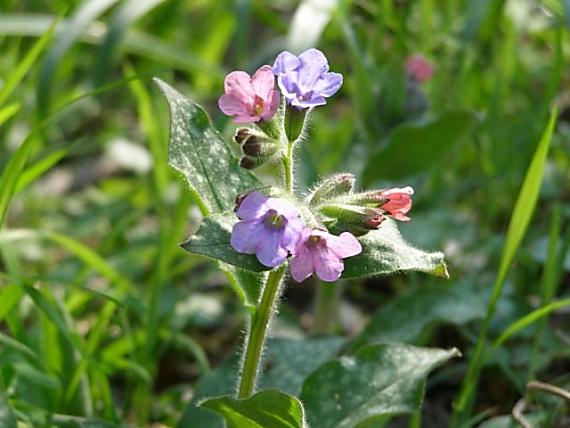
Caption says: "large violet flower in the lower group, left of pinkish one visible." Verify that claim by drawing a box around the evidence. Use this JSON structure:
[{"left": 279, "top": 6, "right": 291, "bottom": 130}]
[{"left": 231, "top": 192, "right": 304, "bottom": 267}]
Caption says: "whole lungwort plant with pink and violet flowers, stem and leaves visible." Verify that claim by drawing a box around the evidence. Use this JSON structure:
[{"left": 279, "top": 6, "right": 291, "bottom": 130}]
[{"left": 157, "top": 49, "right": 458, "bottom": 427}]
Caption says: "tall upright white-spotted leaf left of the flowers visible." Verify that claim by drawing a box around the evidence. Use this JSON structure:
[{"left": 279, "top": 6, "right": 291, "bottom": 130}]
[{"left": 155, "top": 79, "right": 260, "bottom": 214}]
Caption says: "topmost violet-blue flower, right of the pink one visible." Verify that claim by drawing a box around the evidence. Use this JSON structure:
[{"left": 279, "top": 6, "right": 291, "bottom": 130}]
[{"left": 273, "top": 49, "right": 342, "bottom": 109}]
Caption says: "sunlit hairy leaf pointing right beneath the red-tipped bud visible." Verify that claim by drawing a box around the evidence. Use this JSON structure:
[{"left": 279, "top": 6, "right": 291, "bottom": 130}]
[{"left": 342, "top": 219, "right": 448, "bottom": 278}]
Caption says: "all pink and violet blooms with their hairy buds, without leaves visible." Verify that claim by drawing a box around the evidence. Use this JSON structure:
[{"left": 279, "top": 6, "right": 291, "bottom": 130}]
[{"left": 218, "top": 49, "right": 413, "bottom": 282}]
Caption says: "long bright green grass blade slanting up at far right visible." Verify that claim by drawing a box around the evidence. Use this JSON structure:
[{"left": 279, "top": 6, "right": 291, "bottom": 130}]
[{"left": 452, "top": 109, "right": 558, "bottom": 426}]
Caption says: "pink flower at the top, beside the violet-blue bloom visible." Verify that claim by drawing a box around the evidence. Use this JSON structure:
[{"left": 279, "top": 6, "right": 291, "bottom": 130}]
[{"left": 218, "top": 65, "right": 279, "bottom": 123}]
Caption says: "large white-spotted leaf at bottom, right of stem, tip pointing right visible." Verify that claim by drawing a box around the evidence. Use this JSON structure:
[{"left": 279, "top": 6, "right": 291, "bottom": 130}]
[{"left": 301, "top": 345, "right": 460, "bottom": 428}]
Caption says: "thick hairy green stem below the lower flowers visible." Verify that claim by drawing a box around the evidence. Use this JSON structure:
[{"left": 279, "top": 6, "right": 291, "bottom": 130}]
[{"left": 238, "top": 265, "right": 286, "bottom": 398}]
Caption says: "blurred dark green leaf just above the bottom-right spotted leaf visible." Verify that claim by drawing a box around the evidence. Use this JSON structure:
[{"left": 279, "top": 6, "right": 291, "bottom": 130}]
[{"left": 351, "top": 282, "right": 487, "bottom": 349}]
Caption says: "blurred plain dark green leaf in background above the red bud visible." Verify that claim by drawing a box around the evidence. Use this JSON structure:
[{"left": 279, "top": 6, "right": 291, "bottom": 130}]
[{"left": 363, "top": 111, "right": 475, "bottom": 183}]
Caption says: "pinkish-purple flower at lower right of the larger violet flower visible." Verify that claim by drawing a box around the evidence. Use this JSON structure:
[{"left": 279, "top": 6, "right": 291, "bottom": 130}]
[{"left": 291, "top": 228, "right": 362, "bottom": 282}]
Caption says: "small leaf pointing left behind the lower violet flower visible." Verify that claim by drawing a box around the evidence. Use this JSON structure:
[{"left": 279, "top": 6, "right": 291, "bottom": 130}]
[{"left": 182, "top": 213, "right": 270, "bottom": 272}]
